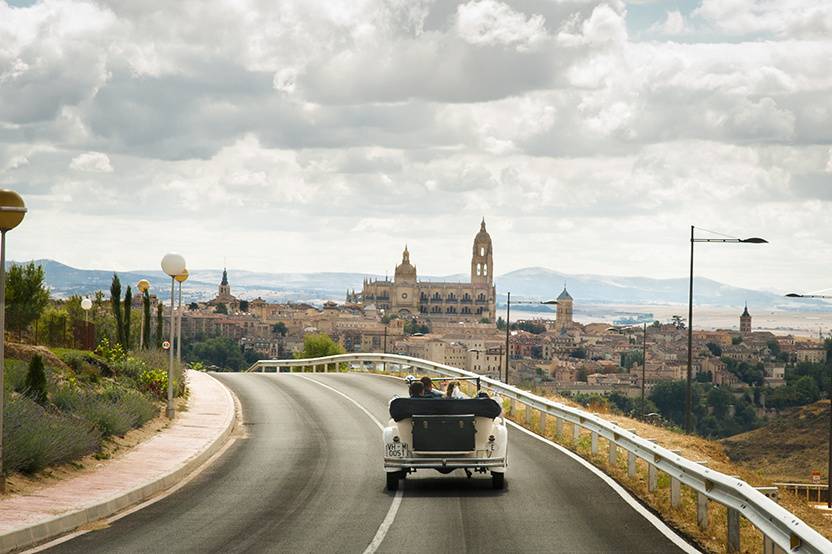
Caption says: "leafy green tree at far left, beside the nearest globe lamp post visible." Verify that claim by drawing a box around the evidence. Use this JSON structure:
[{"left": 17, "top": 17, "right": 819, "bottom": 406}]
[{"left": 6, "top": 262, "right": 49, "bottom": 339}]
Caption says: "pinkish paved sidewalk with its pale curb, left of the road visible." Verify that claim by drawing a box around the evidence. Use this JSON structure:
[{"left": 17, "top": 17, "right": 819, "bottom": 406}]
[{"left": 0, "top": 371, "right": 236, "bottom": 552}]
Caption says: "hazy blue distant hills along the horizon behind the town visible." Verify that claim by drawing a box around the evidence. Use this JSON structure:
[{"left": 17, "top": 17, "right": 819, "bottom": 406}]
[{"left": 14, "top": 260, "right": 832, "bottom": 311}]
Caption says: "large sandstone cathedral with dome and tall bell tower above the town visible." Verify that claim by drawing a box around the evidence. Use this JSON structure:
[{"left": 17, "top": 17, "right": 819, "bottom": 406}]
[{"left": 347, "top": 219, "right": 496, "bottom": 322}]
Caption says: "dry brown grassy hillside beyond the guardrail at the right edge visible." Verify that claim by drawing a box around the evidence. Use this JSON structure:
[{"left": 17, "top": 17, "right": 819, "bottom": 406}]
[{"left": 721, "top": 400, "right": 829, "bottom": 482}]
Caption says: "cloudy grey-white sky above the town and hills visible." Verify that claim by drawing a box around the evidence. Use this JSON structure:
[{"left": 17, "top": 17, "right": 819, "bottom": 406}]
[{"left": 0, "top": 0, "right": 832, "bottom": 292}]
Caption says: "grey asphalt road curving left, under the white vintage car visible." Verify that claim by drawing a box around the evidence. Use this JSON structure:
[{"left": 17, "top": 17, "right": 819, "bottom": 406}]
[{"left": 44, "top": 374, "right": 679, "bottom": 554}]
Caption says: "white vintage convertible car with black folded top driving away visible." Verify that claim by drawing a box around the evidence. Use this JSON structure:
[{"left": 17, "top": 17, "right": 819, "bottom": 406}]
[{"left": 383, "top": 382, "right": 508, "bottom": 491}]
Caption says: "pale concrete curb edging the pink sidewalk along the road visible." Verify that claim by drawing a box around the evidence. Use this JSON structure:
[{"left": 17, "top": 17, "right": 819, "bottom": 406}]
[{"left": 0, "top": 373, "right": 238, "bottom": 553}]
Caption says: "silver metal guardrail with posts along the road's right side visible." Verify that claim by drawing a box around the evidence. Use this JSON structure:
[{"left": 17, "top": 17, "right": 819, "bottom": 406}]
[{"left": 248, "top": 353, "right": 832, "bottom": 554}]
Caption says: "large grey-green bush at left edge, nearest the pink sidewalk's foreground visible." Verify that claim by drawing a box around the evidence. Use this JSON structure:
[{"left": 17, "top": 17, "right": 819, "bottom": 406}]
[{"left": 3, "top": 394, "right": 101, "bottom": 473}]
